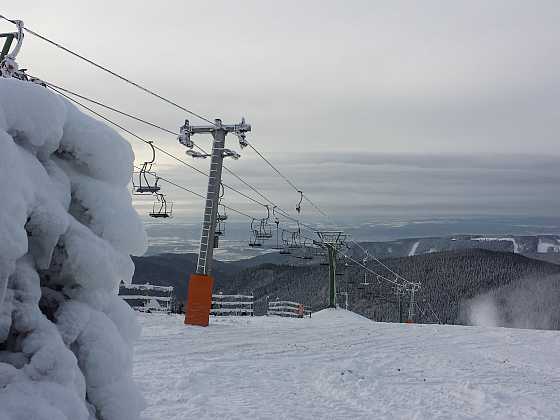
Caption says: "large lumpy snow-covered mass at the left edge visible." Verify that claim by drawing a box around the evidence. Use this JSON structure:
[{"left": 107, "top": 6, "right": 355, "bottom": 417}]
[{"left": 0, "top": 78, "right": 146, "bottom": 420}]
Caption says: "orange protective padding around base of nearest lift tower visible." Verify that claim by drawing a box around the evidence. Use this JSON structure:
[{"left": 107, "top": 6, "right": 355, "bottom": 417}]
[{"left": 185, "top": 274, "right": 214, "bottom": 327}]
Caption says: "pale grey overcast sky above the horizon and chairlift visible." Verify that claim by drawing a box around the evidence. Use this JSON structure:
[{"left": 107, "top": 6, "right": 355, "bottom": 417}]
[{"left": 4, "top": 0, "right": 560, "bottom": 228}]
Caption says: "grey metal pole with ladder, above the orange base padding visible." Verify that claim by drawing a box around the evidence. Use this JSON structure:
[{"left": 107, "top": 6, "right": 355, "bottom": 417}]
[{"left": 196, "top": 119, "right": 226, "bottom": 275}]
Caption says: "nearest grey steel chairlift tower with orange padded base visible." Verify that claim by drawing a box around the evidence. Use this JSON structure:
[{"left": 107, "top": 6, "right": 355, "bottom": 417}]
[{"left": 178, "top": 119, "right": 251, "bottom": 326}]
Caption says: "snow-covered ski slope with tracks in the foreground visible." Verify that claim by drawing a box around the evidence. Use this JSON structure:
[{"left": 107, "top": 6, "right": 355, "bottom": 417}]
[{"left": 134, "top": 310, "right": 560, "bottom": 420}]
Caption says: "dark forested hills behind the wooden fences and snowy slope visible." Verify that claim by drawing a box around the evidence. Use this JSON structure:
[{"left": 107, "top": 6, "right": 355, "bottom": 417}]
[{"left": 134, "top": 249, "right": 560, "bottom": 328}]
